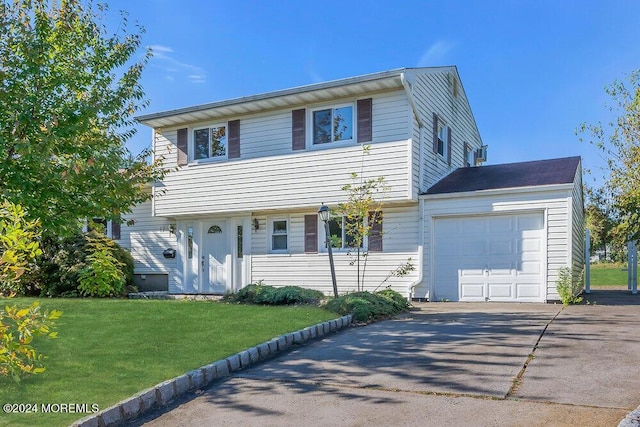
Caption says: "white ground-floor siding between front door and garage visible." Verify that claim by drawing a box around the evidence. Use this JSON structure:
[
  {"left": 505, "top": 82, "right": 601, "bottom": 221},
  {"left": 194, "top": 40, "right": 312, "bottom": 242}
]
[{"left": 251, "top": 207, "right": 418, "bottom": 296}]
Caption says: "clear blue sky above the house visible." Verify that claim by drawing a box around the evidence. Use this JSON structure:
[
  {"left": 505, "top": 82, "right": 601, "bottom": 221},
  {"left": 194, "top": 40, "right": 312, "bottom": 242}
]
[{"left": 107, "top": 0, "right": 640, "bottom": 187}]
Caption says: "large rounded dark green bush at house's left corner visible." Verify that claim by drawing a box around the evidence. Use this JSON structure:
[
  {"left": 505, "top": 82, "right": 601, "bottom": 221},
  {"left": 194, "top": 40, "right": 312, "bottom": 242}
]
[{"left": 30, "top": 231, "right": 134, "bottom": 297}]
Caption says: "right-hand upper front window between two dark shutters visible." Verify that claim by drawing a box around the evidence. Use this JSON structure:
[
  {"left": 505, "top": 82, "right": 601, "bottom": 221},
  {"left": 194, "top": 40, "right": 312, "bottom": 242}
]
[{"left": 311, "top": 104, "right": 353, "bottom": 145}]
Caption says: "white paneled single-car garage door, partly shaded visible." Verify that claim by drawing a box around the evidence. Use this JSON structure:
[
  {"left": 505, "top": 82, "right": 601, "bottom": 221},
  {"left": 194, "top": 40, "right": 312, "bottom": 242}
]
[{"left": 432, "top": 213, "right": 545, "bottom": 302}]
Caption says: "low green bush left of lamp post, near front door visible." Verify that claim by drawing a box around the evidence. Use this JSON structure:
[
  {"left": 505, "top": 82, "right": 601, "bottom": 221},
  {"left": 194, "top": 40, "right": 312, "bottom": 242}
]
[{"left": 225, "top": 282, "right": 324, "bottom": 305}]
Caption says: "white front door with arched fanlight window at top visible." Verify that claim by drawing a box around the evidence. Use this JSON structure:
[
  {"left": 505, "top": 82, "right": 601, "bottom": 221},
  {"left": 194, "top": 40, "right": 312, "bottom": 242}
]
[{"left": 200, "top": 221, "right": 231, "bottom": 294}]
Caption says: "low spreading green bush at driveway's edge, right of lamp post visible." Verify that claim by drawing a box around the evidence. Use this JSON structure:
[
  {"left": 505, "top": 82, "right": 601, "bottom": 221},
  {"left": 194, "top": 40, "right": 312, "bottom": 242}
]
[{"left": 325, "top": 289, "right": 409, "bottom": 322}]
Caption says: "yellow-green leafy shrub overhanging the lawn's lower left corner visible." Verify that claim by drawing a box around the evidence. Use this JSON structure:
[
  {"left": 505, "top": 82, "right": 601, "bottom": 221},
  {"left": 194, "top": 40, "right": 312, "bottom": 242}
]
[{"left": 0, "top": 301, "right": 62, "bottom": 382}]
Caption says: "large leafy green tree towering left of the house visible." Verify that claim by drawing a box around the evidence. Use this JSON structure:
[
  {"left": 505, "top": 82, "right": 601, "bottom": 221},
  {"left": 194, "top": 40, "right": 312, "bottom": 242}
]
[{"left": 0, "top": 0, "right": 161, "bottom": 235}]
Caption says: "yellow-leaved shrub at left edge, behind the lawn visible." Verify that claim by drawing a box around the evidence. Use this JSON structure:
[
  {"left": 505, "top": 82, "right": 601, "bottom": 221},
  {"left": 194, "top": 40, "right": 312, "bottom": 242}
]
[{"left": 0, "top": 200, "right": 42, "bottom": 296}]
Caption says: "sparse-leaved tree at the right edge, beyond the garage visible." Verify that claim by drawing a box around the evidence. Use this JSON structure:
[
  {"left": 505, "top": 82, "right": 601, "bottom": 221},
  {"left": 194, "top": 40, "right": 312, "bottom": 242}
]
[{"left": 578, "top": 70, "right": 640, "bottom": 244}]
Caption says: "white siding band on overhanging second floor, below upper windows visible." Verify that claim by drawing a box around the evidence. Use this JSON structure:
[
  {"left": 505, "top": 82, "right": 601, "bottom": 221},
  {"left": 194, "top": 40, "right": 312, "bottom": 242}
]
[{"left": 155, "top": 140, "right": 410, "bottom": 217}]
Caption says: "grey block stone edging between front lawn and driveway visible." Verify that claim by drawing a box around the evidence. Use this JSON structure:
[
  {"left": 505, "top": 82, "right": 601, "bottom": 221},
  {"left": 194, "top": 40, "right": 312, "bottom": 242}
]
[{"left": 71, "top": 314, "right": 353, "bottom": 427}]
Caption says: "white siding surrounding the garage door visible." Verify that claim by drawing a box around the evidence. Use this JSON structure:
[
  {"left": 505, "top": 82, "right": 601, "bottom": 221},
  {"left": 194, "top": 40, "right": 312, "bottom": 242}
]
[{"left": 422, "top": 185, "right": 573, "bottom": 301}]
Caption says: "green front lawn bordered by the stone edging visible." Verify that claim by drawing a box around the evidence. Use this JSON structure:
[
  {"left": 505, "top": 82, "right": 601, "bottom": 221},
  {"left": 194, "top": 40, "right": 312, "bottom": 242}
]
[{"left": 0, "top": 298, "right": 337, "bottom": 426}]
